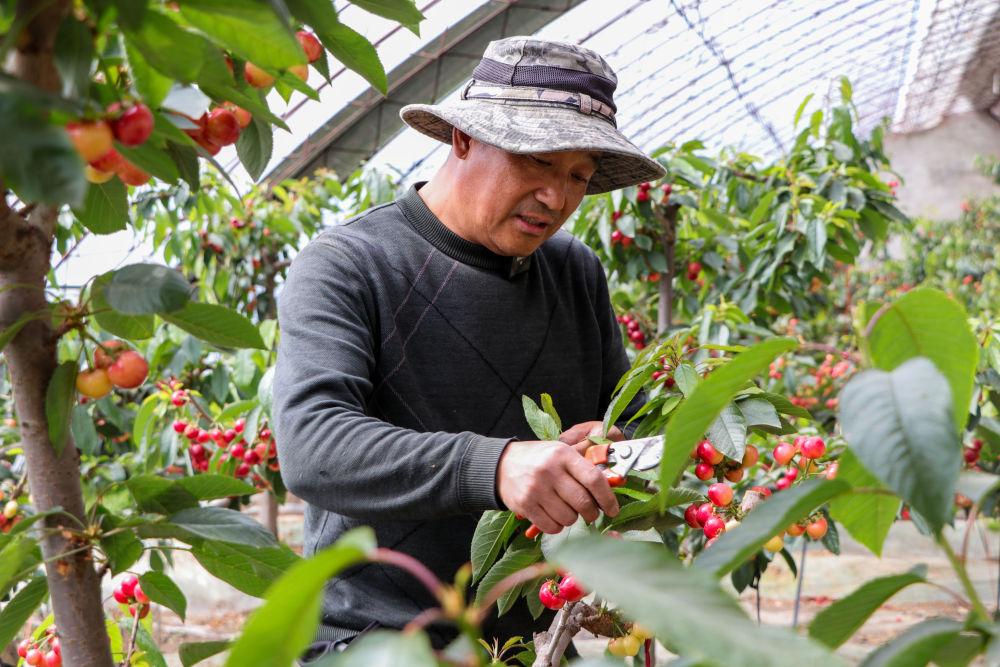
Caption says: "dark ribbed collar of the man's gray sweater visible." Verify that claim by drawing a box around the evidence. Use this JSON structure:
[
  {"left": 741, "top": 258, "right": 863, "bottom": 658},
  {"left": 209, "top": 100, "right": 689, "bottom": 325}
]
[{"left": 397, "top": 181, "right": 531, "bottom": 278}]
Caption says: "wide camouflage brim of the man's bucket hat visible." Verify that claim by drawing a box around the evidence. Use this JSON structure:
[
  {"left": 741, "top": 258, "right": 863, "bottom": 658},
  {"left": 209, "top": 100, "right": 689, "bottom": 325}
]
[{"left": 399, "top": 100, "right": 666, "bottom": 194}]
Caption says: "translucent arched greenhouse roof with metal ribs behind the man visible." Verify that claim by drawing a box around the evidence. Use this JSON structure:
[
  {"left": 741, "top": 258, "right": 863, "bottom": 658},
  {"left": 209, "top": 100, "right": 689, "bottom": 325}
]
[{"left": 240, "top": 0, "right": 1000, "bottom": 188}]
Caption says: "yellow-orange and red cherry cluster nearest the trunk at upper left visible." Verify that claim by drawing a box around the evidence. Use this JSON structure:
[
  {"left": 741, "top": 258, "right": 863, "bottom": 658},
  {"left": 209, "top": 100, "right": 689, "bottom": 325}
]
[{"left": 66, "top": 102, "right": 154, "bottom": 185}]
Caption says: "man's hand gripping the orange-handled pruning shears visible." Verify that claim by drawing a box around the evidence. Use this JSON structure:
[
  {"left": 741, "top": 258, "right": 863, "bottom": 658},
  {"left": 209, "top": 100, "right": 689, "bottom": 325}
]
[{"left": 497, "top": 440, "right": 618, "bottom": 533}]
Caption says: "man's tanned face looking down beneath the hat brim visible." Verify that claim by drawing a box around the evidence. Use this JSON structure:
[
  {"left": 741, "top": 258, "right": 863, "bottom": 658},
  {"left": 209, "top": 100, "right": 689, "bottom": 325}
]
[{"left": 461, "top": 139, "right": 597, "bottom": 257}]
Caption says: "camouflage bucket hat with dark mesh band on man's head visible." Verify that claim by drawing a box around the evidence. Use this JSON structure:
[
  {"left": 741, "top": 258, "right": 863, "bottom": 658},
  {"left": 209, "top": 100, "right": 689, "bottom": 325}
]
[{"left": 399, "top": 37, "right": 665, "bottom": 194}]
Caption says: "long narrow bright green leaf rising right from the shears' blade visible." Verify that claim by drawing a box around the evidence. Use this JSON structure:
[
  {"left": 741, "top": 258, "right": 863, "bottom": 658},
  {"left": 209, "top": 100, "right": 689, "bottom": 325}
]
[{"left": 660, "top": 338, "right": 797, "bottom": 498}]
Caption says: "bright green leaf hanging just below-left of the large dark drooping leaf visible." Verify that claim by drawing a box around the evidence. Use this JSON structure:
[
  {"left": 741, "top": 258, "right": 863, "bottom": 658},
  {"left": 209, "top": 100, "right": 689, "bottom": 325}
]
[{"left": 830, "top": 449, "right": 901, "bottom": 556}]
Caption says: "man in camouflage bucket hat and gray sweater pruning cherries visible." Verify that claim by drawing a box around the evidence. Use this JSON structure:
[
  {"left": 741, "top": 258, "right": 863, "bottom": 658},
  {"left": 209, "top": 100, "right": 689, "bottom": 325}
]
[{"left": 274, "top": 37, "right": 663, "bottom": 660}]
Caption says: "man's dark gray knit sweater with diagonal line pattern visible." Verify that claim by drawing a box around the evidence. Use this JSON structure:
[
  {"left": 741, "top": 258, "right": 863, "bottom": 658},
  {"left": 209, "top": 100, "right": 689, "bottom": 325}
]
[{"left": 273, "top": 183, "right": 637, "bottom": 646}]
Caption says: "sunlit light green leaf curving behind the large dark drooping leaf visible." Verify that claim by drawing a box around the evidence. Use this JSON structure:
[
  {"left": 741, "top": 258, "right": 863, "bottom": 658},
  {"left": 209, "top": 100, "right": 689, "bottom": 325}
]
[{"left": 868, "top": 288, "right": 979, "bottom": 431}]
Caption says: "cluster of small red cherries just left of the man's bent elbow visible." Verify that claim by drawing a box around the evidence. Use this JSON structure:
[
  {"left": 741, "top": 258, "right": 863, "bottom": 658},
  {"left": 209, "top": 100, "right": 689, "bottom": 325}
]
[{"left": 167, "top": 380, "right": 280, "bottom": 488}]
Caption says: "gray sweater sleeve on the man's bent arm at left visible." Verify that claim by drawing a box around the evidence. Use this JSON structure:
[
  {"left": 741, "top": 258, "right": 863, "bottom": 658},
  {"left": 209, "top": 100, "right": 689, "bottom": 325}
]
[{"left": 273, "top": 239, "right": 509, "bottom": 520}]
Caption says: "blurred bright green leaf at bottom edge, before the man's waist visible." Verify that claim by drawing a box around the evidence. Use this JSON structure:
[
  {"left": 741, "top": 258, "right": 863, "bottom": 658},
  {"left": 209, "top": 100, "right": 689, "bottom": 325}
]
[{"left": 226, "top": 528, "right": 376, "bottom": 667}]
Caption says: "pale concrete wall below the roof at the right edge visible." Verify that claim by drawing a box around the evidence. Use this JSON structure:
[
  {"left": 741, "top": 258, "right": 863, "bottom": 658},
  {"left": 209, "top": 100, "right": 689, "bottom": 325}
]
[{"left": 885, "top": 111, "right": 1000, "bottom": 218}]
